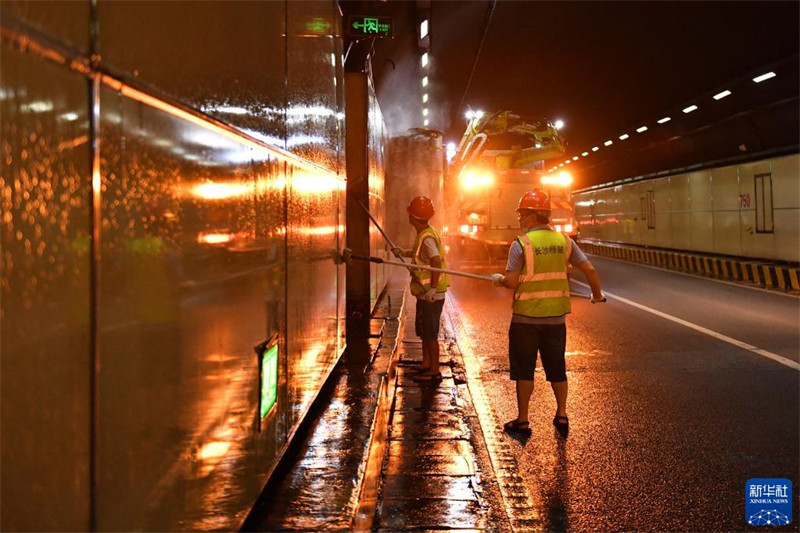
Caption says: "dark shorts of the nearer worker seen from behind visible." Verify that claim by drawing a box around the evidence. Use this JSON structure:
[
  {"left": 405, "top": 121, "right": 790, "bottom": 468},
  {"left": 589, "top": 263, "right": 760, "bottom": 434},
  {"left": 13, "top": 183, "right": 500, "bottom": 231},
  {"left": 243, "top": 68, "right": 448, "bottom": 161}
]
[{"left": 508, "top": 322, "right": 567, "bottom": 383}]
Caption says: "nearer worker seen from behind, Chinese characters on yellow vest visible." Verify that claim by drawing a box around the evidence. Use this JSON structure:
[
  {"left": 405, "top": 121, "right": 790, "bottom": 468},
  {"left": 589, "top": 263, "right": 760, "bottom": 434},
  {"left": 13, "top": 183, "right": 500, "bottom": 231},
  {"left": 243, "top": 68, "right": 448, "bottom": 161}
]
[{"left": 492, "top": 190, "right": 606, "bottom": 436}]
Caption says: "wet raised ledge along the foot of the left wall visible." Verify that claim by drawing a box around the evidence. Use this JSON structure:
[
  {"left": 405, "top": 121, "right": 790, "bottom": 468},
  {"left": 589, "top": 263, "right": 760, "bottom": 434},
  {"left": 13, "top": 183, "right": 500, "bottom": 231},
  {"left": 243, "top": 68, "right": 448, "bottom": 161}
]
[{"left": 240, "top": 281, "right": 407, "bottom": 531}]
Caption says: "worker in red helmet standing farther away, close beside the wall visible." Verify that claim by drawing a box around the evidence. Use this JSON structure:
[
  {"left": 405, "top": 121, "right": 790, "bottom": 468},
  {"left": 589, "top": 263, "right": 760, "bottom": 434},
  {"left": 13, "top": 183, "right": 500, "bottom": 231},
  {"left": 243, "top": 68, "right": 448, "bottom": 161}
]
[{"left": 392, "top": 196, "right": 450, "bottom": 385}]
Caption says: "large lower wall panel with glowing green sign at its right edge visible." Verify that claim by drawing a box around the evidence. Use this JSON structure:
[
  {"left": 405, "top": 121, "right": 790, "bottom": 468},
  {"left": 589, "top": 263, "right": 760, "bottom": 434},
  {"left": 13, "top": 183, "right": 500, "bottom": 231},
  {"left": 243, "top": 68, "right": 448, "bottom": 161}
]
[{"left": 97, "top": 89, "right": 292, "bottom": 530}]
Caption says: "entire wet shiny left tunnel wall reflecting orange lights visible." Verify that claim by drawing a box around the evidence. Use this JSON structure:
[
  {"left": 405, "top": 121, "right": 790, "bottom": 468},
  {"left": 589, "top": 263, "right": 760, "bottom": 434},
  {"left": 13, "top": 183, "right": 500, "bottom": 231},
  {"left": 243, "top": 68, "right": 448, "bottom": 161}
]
[{"left": 0, "top": 1, "right": 384, "bottom": 531}]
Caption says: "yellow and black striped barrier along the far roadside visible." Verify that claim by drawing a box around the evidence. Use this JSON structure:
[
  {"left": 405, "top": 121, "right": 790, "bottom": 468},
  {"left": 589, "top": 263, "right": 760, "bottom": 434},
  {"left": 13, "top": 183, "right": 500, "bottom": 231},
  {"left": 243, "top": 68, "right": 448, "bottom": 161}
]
[{"left": 578, "top": 241, "right": 800, "bottom": 292}]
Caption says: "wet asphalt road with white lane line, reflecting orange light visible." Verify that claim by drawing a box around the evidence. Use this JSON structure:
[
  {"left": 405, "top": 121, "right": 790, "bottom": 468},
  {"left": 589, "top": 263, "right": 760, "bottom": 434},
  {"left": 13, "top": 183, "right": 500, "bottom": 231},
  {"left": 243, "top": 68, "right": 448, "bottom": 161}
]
[{"left": 450, "top": 257, "right": 800, "bottom": 531}]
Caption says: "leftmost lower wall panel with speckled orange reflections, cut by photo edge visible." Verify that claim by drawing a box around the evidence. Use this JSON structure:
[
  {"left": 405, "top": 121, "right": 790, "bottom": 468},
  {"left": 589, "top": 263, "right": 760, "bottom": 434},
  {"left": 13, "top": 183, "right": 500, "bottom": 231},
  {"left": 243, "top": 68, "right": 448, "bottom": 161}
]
[{"left": 0, "top": 40, "right": 92, "bottom": 531}]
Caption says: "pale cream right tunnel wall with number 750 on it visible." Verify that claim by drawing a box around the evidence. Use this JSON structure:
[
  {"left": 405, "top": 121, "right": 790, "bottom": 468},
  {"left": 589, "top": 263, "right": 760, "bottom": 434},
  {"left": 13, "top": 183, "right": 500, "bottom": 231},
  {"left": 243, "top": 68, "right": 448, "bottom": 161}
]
[{"left": 572, "top": 154, "right": 800, "bottom": 262}]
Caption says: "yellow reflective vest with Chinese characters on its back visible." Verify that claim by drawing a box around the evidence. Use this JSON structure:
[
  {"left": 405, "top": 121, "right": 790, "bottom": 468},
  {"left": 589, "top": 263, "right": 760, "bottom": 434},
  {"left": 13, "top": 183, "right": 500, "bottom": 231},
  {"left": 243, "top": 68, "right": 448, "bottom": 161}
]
[{"left": 513, "top": 230, "right": 572, "bottom": 318}]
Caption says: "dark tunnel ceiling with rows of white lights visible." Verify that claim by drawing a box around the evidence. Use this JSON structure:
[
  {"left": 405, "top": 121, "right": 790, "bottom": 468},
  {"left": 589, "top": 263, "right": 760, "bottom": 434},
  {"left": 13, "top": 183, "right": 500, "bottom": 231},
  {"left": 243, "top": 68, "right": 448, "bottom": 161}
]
[{"left": 362, "top": 0, "right": 800, "bottom": 186}]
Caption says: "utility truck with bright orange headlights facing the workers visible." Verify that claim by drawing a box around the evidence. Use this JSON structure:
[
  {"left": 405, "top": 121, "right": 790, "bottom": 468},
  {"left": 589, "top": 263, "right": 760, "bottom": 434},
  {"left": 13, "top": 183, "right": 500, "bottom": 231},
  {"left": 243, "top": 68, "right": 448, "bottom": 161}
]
[{"left": 444, "top": 111, "right": 577, "bottom": 270}]
